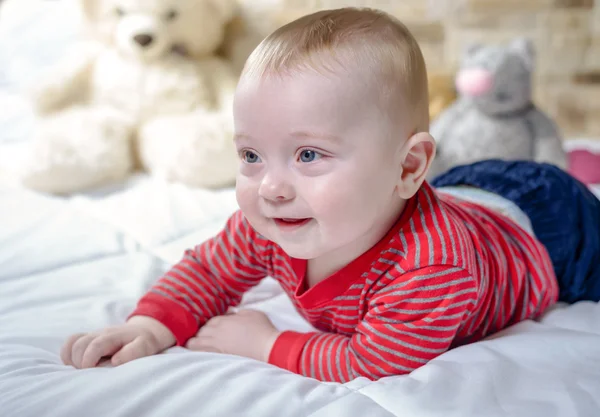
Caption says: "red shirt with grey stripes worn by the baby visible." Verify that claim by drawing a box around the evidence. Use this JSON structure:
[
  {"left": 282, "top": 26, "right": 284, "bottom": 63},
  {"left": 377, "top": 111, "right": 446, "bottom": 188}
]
[{"left": 133, "top": 184, "right": 558, "bottom": 382}]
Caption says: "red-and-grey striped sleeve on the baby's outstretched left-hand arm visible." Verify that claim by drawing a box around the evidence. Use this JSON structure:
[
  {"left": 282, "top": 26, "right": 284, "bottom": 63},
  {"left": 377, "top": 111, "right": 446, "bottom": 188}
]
[{"left": 130, "top": 211, "right": 268, "bottom": 346}]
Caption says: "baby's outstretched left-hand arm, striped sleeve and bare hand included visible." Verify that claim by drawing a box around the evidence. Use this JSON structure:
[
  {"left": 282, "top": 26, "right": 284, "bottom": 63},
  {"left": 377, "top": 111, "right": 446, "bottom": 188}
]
[{"left": 61, "top": 212, "right": 267, "bottom": 368}]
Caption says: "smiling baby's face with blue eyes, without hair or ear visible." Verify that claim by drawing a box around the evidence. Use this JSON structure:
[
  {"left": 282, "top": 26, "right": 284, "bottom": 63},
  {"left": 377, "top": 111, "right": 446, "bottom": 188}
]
[{"left": 234, "top": 68, "right": 402, "bottom": 259}]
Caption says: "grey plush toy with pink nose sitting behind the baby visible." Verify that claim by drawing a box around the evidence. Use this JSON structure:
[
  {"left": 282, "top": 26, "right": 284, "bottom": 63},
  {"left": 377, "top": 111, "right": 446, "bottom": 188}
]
[{"left": 429, "top": 38, "right": 566, "bottom": 178}]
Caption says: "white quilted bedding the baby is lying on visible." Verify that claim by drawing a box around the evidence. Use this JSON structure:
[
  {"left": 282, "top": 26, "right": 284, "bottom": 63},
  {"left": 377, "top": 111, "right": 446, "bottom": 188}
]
[{"left": 0, "top": 0, "right": 600, "bottom": 417}]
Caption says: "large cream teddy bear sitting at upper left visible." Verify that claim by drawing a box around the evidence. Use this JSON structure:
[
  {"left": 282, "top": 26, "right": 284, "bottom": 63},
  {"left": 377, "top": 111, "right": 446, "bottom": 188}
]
[{"left": 20, "top": 0, "right": 238, "bottom": 194}]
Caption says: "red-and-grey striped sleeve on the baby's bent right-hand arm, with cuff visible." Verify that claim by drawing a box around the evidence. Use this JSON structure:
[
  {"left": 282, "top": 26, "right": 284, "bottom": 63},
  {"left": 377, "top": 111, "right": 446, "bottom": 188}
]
[{"left": 269, "top": 266, "right": 477, "bottom": 382}]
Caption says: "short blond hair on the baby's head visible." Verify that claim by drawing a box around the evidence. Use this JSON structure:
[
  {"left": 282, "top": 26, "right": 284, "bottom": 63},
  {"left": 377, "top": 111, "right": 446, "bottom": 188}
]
[{"left": 242, "top": 7, "right": 429, "bottom": 134}]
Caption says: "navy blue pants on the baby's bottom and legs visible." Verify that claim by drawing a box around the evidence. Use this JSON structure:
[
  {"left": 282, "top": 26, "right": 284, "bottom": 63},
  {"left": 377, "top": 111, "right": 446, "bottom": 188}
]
[{"left": 431, "top": 160, "right": 600, "bottom": 303}]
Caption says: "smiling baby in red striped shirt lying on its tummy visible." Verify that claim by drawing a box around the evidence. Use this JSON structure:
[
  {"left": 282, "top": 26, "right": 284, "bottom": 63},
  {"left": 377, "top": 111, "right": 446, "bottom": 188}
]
[{"left": 61, "top": 8, "right": 600, "bottom": 382}]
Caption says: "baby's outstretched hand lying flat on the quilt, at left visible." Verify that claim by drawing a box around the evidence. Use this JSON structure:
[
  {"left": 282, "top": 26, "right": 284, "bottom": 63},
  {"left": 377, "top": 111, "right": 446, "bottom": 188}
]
[{"left": 60, "top": 316, "right": 175, "bottom": 369}]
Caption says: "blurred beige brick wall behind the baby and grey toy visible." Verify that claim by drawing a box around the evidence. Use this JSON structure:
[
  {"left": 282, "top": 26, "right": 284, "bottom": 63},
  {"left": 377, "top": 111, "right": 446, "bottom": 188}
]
[{"left": 240, "top": 0, "right": 600, "bottom": 138}]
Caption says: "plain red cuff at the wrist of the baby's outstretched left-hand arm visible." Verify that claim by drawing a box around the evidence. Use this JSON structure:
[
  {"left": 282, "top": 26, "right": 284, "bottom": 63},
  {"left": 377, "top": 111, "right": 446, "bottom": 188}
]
[{"left": 127, "top": 294, "right": 198, "bottom": 346}]
